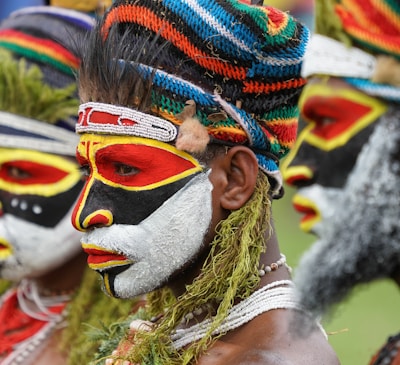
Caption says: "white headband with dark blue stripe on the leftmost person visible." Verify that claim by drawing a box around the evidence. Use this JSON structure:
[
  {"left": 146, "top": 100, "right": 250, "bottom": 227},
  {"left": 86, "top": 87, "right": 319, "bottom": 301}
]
[{"left": 0, "top": 111, "right": 79, "bottom": 156}]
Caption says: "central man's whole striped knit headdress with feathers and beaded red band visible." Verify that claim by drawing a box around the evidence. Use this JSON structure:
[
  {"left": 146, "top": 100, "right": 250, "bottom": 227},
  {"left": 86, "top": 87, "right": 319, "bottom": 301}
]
[{"left": 77, "top": 0, "right": 309, "bottom": 194}]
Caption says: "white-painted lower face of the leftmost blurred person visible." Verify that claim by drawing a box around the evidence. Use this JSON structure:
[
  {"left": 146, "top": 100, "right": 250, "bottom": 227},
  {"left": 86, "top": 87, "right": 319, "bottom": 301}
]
[{"left": 0, "top": 208, "right": 82, "bottom": 281}]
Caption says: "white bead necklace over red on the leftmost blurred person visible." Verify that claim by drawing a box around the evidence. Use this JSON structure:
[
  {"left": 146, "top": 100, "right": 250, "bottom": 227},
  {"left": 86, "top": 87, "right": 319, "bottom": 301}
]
[{"left": 1, "top": 280, "right": 71, "bottom": 365}]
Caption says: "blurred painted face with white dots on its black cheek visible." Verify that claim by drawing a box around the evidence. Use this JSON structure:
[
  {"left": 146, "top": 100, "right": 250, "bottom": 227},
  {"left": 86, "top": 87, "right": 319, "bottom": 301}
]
[{"left": 0, "top": 149, "right": 83, "bottom": 281}]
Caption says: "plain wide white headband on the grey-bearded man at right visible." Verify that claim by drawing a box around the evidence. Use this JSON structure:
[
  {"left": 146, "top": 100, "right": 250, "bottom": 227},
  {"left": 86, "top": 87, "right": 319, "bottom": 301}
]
[{"left": 301, "top": 34, "right": 376, "bottom": 80}]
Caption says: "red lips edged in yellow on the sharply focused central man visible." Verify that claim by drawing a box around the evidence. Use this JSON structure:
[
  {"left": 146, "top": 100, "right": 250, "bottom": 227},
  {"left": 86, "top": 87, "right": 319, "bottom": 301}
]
[{"left": 82, "top": 243, "right": 133, "bottom": 271}]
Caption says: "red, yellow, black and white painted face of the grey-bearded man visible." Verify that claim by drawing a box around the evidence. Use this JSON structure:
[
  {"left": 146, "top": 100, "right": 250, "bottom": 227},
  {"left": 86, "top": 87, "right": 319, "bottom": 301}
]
[{"left": 282, "top": 78, "right": 386, "bottom": 236}]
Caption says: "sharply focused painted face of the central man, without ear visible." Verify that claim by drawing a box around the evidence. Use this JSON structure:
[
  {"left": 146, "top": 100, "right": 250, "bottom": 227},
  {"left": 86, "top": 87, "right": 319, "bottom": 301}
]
[{"left": 72, "top": 135, "right": 212, "bottom": 298}]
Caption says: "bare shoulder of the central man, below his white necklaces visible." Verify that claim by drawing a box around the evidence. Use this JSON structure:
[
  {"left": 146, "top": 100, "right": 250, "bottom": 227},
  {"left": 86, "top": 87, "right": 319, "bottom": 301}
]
[{"left": 197, "top": 310, "right": 340, "bottom": 365}]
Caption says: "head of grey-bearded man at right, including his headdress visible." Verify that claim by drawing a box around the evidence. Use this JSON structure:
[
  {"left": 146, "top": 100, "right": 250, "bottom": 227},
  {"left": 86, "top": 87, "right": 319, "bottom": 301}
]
[{"left": 283, "top": 0, "right": 400, "bottom": 365}]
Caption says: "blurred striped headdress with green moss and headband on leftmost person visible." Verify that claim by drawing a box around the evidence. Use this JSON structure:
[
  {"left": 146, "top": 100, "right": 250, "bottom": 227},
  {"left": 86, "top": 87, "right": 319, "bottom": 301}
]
[{"left": 0, "top": 6, "right": 95, "bottom": 155}]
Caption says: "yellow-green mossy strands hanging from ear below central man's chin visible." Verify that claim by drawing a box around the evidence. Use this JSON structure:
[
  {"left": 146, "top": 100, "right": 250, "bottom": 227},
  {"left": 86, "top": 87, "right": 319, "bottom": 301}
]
[{"left": 119, "top": 172, "right": 272, "bottom": 365}]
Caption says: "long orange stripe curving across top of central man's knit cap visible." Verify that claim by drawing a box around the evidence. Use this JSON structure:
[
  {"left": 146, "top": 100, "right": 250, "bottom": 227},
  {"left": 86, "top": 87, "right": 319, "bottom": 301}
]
[{"left": 103, "top": 5, "right": 246, "bottom": 80}]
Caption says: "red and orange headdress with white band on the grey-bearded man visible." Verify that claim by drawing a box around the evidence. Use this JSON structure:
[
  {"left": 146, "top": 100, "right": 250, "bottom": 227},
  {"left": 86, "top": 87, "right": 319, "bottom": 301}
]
[{"left": 302, "top": 0, "right": 400, "bottom": 102}]
